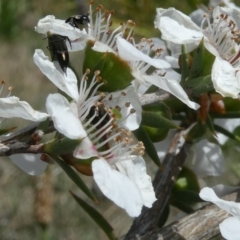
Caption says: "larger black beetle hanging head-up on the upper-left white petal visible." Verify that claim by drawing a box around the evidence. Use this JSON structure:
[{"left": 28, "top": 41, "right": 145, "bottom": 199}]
[{"left": 47, "top": 34, "right": 72, "bottom": 75}]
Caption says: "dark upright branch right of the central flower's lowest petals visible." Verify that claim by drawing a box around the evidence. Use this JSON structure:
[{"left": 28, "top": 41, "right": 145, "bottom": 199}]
[{"left": 125, "top": 131, "right": 192, "bottom": 240}]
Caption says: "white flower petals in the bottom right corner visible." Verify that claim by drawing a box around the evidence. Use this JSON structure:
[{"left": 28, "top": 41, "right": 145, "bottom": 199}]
[{"left": 199, "top": 187, "right": 240, "bottom": 240}]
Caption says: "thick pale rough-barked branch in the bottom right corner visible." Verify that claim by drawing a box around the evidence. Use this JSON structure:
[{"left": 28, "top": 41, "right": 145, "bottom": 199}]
[{"left": 129, "top": 190, "right": 240, "bottom": 240}]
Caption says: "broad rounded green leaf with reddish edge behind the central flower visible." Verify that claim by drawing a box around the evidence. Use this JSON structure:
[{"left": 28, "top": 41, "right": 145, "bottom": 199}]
[{"left": 83, "top": 41, "right": 134, "bottom": 92}]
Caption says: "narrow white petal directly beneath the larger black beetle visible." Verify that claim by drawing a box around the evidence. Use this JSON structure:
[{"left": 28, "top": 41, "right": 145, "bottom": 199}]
[{"left": 33, "top": 49, "right": 78, "bottom": 101}]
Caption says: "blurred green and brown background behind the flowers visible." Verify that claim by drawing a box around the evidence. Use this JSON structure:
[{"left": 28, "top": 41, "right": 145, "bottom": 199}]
[{"left": 0, "top": 0, "right": 240, "bottom": 240}]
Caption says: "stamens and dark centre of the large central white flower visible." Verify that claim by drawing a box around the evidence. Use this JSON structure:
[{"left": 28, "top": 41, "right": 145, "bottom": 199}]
[{"left": 78, "top": 72, "right": 145, "bottom": 163}]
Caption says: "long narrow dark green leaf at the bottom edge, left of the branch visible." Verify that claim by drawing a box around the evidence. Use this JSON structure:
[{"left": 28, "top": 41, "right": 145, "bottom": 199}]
[{"left": 70, "top": 191, "right": 117, "bottom": 240}]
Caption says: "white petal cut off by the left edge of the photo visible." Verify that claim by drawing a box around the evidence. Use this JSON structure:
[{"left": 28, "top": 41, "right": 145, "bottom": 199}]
[{"left": 0, "top": 97, "right": 48, "bottom": 122}]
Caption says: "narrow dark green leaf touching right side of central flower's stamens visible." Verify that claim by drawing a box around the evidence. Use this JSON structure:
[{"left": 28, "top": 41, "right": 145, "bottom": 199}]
[{"left": 133, "top": 126, "right": 161, "bottom": 167}]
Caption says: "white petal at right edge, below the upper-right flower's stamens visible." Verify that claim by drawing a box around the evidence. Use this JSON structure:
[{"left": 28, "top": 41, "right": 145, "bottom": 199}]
[{"left": 212, "top": 57, "right": 240, "bottom": 98}]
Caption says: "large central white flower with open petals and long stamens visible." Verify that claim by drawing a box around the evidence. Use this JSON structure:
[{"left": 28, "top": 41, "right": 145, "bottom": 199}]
[{"left": 34, "top": 53, "right": 156, "bottom": 217}]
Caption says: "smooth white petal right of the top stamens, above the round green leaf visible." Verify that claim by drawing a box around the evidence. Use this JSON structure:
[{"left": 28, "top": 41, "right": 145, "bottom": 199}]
[{"left": 117, "top": 37, "right": 171, "bottom": 68}]
